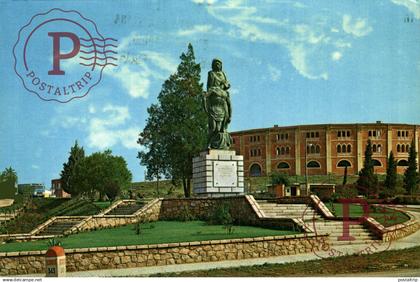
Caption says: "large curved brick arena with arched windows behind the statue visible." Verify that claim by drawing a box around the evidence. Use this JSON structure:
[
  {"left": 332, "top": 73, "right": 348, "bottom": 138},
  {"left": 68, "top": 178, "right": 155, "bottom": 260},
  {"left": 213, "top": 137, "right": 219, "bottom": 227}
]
[{"left": 231, "top": 121, "right": 420, "bottom": 176}]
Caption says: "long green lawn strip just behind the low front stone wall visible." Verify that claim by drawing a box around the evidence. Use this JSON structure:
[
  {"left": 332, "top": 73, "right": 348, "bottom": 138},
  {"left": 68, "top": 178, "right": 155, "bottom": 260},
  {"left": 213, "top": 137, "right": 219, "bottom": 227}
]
[{"left": 0, "top": 221, "right": 298, "bottom": 252}]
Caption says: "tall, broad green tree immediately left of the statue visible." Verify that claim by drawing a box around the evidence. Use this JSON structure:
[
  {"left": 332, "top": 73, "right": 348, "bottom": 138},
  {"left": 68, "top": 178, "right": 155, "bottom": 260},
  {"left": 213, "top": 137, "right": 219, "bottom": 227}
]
[{"left": 138, "top": 44, "right": 207, "bottom": 197}]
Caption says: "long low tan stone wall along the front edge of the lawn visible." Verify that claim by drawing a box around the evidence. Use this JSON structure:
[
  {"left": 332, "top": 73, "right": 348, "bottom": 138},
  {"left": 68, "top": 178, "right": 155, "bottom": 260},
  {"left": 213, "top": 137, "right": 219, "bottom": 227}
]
[{"left": 0, "top": 235, "right": 328, "bottom": 276}]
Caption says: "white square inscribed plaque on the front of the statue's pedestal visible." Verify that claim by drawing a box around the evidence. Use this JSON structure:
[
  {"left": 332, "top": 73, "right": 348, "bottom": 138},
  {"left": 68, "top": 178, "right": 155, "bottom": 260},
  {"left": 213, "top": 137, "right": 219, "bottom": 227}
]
[{"left": 213, "top": 161, "right": 238, "bottom": 187}]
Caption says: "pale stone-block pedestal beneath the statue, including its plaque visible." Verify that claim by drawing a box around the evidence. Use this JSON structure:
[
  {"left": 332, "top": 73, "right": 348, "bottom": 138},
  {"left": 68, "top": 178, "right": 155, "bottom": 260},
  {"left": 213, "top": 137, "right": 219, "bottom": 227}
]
[{"left": 193, "top": 150, "right": 244, "bottom": 197}]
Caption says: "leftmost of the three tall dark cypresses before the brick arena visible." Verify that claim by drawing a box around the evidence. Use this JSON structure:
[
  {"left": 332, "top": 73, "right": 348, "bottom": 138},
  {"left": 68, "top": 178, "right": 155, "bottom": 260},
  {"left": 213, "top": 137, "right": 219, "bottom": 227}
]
[{"left": 357, "top": 139, "right": 378, "bottom": 196}]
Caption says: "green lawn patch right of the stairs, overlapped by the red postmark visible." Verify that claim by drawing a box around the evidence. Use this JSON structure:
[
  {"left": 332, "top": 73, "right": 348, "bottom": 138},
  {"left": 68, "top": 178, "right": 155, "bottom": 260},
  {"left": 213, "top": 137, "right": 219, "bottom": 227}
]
[{"left": 326, "top": 203, "right": 410, "bottom": 227}]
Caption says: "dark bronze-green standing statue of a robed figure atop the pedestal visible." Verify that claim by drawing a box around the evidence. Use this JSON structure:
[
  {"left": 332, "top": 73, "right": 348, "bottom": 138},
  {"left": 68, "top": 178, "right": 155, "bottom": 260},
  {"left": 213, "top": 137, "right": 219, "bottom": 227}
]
[{"left": 203, "top": 59, "right": 232, "bottom": 150}]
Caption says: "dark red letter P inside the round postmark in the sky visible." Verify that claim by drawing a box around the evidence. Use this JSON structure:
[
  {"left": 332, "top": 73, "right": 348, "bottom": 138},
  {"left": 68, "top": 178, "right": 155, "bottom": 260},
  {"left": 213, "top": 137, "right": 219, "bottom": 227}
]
[{"left": 48, "top": 32, "right": 80, "bottom": 75}]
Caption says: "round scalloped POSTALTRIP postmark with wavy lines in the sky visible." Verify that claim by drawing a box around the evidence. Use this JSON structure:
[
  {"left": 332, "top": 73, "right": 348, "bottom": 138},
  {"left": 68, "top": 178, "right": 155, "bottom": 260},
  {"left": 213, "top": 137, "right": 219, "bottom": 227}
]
[{"left": 13, "top": 8, "right": 117, "bottom": 103}]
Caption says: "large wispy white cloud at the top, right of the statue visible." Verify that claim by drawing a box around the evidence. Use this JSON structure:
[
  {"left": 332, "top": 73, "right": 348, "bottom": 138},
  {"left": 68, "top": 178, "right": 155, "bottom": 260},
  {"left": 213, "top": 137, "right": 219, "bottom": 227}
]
[{"left": 207, "top": 0, "right": 354, "bottom": 80}]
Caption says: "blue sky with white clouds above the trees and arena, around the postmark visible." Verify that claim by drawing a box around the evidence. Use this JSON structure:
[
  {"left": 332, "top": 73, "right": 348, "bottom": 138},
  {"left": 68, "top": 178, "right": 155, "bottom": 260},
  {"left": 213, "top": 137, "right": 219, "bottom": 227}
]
[{"left": 0, "top": 0, "right": 420, "bottom": 187}]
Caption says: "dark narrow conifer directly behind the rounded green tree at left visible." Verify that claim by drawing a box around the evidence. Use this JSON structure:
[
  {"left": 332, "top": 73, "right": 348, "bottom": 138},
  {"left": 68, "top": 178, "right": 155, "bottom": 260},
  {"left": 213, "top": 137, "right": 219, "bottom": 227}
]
[{"left": 60, "top": 140, "right": 85, "bottom": 196}]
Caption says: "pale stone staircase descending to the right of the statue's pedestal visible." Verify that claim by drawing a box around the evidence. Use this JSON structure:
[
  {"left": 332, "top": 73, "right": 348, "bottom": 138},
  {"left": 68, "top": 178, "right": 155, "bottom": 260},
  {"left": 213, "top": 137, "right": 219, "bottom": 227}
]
[{"left": 257, "top": 200, "right": 377, "bottom": 245}]
